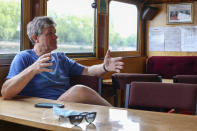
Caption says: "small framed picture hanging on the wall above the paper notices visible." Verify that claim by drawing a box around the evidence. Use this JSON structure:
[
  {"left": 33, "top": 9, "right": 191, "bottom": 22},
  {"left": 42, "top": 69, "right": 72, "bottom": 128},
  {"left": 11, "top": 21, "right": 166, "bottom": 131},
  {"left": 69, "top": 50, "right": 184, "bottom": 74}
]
[{"left": 167, "top": 3, "right": 193, "bottom": 24}]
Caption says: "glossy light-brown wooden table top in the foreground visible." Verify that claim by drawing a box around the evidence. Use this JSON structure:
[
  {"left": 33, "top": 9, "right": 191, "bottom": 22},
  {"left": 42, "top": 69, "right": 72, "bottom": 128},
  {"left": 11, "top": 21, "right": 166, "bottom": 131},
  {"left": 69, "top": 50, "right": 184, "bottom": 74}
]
[{"left": 0, "top": 97, "right": 197, "bottom": 131}]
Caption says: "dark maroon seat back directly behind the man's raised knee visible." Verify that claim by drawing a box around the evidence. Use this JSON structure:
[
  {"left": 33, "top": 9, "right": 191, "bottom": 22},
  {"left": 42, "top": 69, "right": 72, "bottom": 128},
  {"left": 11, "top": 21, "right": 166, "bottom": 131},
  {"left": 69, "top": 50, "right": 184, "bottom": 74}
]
[{"left": 70, "top": 75, "right": 102, "bottom": 95}]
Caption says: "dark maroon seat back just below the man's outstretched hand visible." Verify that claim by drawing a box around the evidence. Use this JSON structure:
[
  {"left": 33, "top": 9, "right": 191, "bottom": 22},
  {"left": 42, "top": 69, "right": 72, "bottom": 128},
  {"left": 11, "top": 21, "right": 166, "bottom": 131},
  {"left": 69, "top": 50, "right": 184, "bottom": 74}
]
[{"left": 112, "top": 73, "right": 161, "bottom": 90}]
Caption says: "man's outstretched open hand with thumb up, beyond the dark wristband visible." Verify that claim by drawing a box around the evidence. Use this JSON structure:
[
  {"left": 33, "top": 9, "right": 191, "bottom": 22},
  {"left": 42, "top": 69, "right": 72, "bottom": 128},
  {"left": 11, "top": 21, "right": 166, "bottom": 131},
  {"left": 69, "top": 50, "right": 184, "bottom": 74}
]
[{"left": 104, "top": 50, "right": 124, "bottom": 73}]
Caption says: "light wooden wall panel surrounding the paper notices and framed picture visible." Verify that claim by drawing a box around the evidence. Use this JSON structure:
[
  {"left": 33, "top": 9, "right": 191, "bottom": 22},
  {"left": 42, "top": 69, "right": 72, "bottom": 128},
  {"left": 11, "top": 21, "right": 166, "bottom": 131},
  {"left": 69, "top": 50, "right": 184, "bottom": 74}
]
[{"left": 146, "top": 2, "right": 197, "bottom": 57}]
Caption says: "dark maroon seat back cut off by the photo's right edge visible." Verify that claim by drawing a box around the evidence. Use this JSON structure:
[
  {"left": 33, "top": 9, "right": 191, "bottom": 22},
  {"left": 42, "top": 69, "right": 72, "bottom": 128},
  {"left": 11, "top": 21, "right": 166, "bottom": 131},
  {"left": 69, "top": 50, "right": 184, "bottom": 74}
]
[{"left": 173, "top": 75, "right": 197, "bottom": 84}]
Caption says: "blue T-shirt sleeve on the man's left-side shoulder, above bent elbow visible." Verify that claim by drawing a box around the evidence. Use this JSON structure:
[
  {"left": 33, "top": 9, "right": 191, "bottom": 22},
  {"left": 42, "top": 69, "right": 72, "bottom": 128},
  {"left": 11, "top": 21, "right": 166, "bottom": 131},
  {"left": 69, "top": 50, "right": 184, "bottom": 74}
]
[{"left": 6, "top": 54, "right": 27, "bottom": 79}]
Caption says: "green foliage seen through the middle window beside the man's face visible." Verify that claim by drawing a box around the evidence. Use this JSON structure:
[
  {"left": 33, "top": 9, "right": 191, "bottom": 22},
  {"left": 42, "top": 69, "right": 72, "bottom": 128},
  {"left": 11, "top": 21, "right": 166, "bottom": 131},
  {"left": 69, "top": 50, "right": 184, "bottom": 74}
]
[{"left": 56, "top": 16, "right": 94, "bottom": 45}]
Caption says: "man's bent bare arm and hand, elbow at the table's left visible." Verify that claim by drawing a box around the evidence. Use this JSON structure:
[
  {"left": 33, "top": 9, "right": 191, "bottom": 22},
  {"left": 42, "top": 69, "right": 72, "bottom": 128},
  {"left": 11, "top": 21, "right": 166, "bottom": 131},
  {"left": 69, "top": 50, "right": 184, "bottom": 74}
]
[{"left": 1, "top": 53, "right": 52, "bottom": 99}]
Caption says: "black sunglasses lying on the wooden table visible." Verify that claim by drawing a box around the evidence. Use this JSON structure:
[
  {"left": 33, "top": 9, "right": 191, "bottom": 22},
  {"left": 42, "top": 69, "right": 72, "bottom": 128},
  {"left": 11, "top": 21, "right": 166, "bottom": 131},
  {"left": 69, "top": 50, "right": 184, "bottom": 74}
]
[{"left": 68, "top": 112, "right": 96, "bottom": 126}]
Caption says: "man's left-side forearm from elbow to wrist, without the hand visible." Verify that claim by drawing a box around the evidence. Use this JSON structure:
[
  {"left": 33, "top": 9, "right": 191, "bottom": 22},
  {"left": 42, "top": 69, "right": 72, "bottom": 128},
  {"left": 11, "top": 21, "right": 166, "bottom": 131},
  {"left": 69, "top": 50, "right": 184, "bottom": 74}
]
[{"left": 1, "top": 66, "right": 35, "bottom": 99}]
